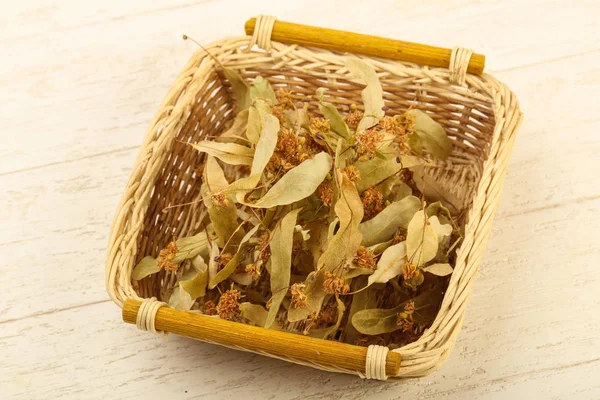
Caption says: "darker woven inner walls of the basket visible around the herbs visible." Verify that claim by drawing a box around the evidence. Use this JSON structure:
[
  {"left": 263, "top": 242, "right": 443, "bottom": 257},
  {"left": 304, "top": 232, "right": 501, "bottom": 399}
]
[{"left": 134, "top": 61, "right": 495, "bottom": 310}]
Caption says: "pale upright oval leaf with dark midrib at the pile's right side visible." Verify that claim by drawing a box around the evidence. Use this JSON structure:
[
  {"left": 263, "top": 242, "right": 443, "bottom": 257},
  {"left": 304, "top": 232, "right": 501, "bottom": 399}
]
[{"left": 406, "top": 210, "right": 438, "bottom": 267}]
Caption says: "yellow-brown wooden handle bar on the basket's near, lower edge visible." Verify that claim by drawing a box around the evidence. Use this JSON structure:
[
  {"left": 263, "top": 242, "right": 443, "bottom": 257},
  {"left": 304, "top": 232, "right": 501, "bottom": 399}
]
[{"left": 123, "top": 299, "right": 401, "bottom": 377}]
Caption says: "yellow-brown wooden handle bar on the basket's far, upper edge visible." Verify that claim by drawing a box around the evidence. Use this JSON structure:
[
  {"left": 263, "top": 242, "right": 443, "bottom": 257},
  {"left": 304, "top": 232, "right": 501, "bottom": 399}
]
[{"left": 245, "top": 18, "right": 485, "bottom": 75}]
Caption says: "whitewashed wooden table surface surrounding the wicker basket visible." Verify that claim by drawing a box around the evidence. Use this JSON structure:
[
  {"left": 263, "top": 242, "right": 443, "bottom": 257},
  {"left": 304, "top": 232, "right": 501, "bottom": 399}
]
[{"left": 0, "top": 0, "right": 600, "bottom": 399}]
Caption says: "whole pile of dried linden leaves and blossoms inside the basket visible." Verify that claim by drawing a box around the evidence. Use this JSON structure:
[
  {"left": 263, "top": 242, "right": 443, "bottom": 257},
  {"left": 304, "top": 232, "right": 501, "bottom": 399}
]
[{"left": 132, "top": 58, "right": 460, "bottom": 348}]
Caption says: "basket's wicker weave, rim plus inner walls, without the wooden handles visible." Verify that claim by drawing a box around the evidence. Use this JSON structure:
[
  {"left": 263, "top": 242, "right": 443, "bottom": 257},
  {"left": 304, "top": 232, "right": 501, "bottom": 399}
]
[{"left": 106, "top": 37, "right": 522, "bottom": 377}]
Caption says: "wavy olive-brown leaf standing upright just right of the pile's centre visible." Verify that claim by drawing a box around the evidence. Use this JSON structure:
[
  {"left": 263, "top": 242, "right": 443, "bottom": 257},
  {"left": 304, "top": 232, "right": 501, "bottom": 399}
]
[{"left": 317, "top": 171, "right": 364, "bottom": 271}]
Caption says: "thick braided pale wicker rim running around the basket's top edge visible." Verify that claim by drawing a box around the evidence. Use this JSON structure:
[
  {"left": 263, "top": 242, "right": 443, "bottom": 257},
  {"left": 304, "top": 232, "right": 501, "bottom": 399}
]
[{"left": 105, "top": 36, "right": 523, "bottom": 377}]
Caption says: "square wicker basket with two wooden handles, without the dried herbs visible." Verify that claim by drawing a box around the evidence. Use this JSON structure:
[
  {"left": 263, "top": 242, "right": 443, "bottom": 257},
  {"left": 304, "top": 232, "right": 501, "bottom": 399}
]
[{"left": 106, "top": 16, "right": 522, "bottom": 379}]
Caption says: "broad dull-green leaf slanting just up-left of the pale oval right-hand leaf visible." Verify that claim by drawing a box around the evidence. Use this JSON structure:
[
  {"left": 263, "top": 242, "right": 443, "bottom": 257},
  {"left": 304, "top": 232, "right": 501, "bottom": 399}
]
[{"left": 358, "top": 196, "right": 421, "bottom": 246}]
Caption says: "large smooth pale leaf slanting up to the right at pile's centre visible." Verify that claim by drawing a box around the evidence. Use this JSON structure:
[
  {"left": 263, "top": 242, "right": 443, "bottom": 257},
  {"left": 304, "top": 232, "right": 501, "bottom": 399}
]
[{"left": 245, "top": 152, "right": 332, "bottom": 208}]
